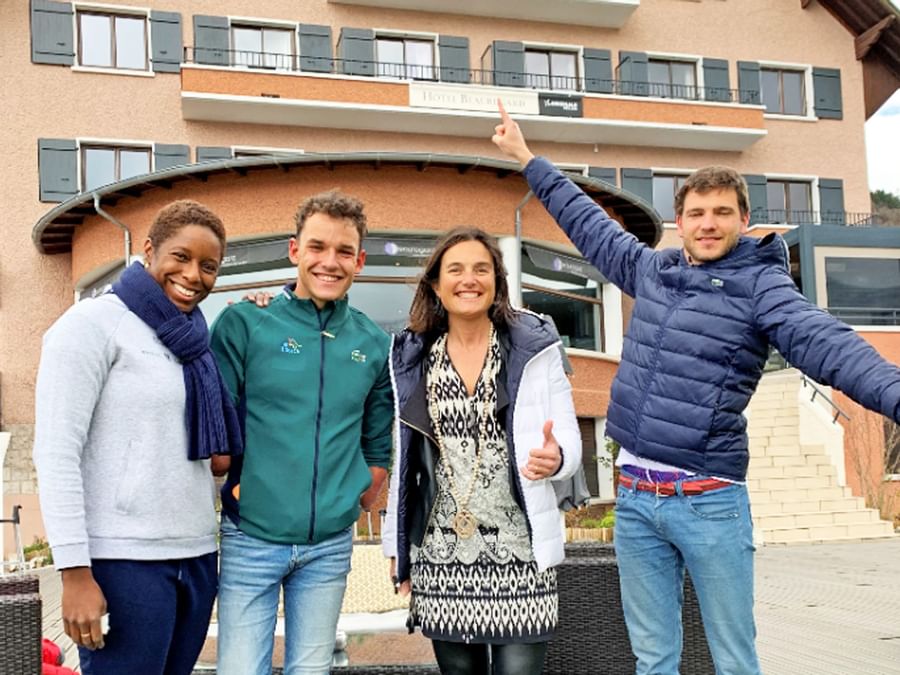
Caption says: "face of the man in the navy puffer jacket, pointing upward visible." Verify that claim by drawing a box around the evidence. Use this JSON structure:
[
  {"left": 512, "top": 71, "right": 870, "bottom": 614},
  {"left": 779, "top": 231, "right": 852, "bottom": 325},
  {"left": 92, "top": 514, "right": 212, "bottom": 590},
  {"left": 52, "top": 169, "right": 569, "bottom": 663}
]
[{"left": 675, "top": 188, "right": 750, "bottom": 264}]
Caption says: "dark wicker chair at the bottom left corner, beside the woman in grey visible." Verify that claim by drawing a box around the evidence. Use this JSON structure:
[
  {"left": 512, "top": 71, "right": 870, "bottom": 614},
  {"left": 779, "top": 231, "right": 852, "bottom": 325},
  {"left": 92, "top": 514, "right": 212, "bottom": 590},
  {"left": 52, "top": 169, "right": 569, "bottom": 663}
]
[{"left": 0, "top": 574, "right": 41, "bottom": 675}]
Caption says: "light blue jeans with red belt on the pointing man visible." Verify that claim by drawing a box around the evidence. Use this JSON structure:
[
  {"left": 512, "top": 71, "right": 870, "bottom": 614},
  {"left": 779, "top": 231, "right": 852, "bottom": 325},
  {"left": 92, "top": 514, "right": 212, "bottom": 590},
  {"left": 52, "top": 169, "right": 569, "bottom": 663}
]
[{"left": 614, "top": 476, "right": 761, "bottom": 675}]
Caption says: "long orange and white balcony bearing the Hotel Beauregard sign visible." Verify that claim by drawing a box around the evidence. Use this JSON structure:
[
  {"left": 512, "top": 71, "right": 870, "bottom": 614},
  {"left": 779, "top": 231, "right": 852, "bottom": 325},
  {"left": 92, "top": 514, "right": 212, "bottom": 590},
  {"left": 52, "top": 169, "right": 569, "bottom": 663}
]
[{"left": 181, "top": 47, "right": 766, "bottom": 152}]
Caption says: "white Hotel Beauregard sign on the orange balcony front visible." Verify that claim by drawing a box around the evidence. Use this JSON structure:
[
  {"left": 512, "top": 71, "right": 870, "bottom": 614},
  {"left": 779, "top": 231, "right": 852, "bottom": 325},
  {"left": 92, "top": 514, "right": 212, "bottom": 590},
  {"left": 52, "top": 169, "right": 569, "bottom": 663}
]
[{"left": 409, "top": 82, "right": 540, "bottom": 115}]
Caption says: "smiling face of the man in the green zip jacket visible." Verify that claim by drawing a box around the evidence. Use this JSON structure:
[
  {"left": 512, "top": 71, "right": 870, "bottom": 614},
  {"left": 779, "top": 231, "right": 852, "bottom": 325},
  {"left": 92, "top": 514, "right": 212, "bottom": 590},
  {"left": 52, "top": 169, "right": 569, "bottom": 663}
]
[{"left": 288, "top": 213, "right": 366, "bottom": 309}]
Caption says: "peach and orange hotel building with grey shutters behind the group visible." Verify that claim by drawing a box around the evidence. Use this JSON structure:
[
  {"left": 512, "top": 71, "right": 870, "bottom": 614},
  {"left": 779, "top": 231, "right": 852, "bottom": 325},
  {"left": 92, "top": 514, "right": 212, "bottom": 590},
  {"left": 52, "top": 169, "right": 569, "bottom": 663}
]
[{"left": 0, "top": 0, "right": 900, "bottom": 556}]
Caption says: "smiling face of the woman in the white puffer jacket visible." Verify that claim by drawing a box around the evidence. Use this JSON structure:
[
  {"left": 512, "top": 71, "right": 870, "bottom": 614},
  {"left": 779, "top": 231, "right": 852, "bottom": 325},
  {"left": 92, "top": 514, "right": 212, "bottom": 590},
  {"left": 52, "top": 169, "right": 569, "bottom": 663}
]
[{"left": 432, "top": 241, "right": 497, "bottom": 320}]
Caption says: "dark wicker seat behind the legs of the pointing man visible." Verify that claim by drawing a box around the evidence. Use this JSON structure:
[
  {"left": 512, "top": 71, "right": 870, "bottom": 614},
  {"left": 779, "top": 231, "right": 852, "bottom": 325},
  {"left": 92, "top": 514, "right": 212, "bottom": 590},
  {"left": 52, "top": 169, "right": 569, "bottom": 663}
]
[{"left": 544, "top": 542, "right": 715, "bottom": 675}]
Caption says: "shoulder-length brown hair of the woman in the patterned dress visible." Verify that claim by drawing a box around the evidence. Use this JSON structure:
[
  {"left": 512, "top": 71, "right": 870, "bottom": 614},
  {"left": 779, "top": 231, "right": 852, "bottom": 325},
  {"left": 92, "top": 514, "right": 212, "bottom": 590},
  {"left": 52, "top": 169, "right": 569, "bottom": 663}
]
[{"left": 409, "top": 227, "right": 515, "bottom": 341}]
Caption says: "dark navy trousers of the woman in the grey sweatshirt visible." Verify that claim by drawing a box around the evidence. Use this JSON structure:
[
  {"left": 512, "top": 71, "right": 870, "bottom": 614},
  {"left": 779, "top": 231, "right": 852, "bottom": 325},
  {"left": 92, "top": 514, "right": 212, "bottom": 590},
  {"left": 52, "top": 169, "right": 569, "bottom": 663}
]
[{"left": 78, "top": 553, "right": 217, "bottom": 675}]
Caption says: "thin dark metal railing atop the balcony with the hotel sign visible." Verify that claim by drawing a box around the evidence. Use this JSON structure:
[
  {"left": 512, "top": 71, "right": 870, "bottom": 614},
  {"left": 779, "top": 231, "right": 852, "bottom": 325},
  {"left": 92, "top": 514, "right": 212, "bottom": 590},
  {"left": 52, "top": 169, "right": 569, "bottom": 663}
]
[{"left": 184, "top": 46, "right": 761, "bottom": 105}]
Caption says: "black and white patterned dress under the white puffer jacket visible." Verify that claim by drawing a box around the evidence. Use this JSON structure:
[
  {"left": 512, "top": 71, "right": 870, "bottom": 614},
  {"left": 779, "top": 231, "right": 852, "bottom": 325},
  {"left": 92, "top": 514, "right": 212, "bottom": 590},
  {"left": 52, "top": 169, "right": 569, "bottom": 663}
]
[{"left": 410, "top": 333, "right": 558, "bottom": 644}]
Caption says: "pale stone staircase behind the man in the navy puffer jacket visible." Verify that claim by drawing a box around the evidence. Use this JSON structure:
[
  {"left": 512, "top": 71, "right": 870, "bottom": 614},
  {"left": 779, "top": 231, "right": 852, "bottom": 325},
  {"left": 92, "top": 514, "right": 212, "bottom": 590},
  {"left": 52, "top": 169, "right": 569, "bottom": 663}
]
[{"left": 747, "top": 369, "right": 894, "bottom": 544}]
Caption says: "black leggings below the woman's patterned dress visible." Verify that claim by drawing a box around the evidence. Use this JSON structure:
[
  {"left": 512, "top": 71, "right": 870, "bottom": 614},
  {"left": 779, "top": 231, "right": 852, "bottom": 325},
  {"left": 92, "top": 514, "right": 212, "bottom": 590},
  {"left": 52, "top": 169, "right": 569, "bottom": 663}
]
[{"left": 431, "top": 640, "right": 547, "bottom": 675}]
